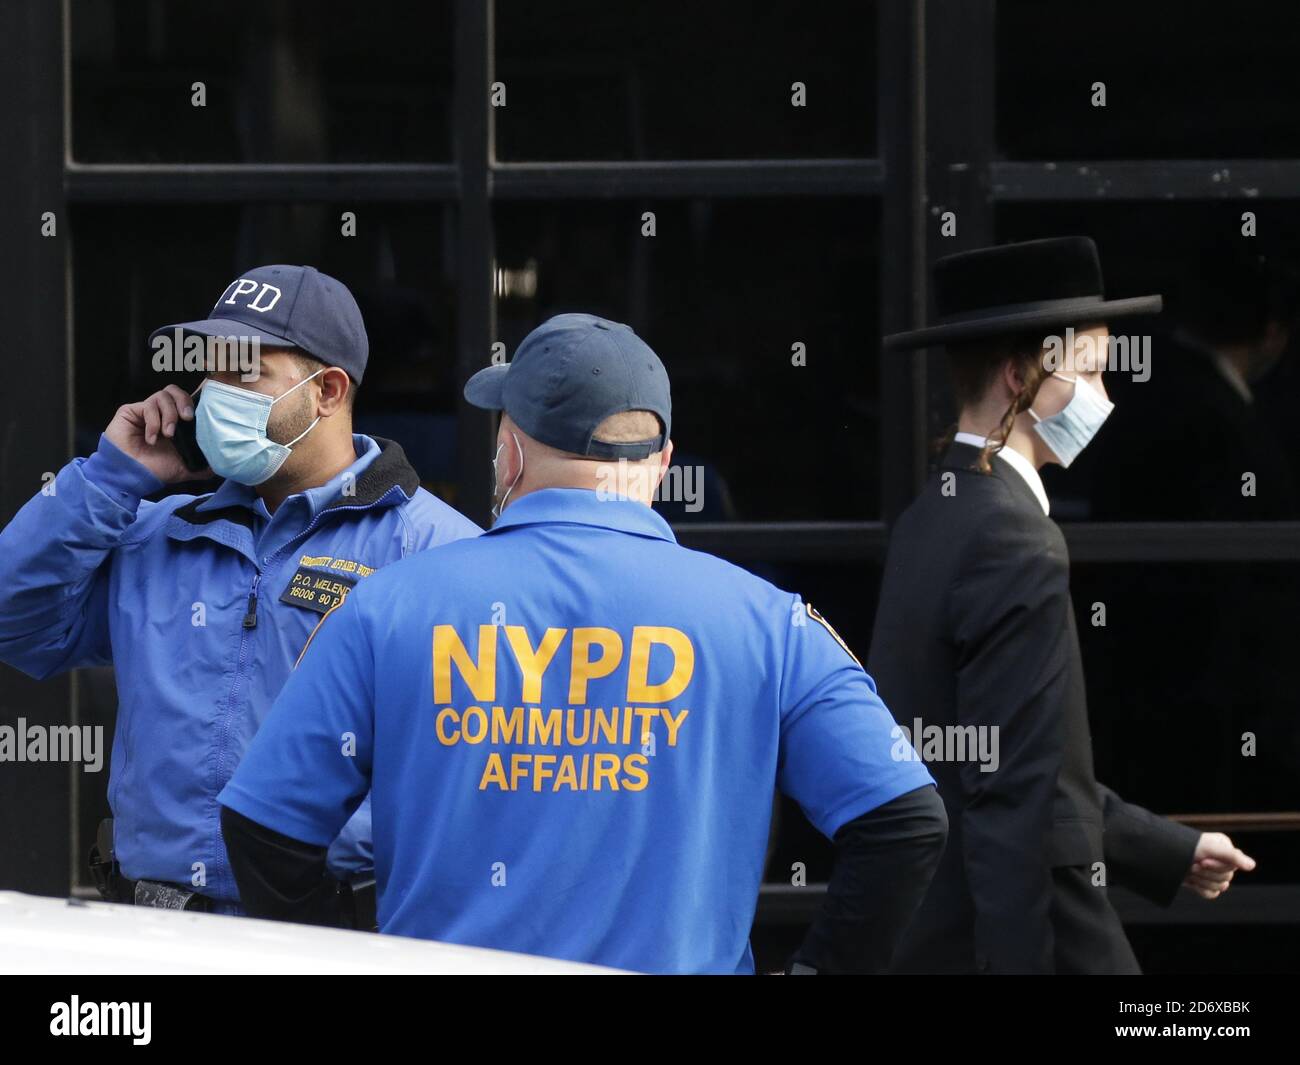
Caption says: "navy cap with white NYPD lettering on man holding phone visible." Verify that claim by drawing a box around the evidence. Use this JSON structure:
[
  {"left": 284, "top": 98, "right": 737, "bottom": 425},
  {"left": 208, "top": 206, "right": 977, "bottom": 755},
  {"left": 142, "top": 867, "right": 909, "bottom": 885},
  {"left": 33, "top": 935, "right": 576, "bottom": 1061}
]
[{"left": 150, "top": 265, "right": 371, "bottom": 384}]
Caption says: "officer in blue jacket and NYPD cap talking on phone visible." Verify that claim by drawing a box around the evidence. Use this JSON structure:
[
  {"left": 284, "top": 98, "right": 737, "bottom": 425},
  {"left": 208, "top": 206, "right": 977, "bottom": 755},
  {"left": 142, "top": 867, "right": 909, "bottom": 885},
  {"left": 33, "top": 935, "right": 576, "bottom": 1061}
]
[{"left": 0, "top": 265, "right": 478, "bottom": 913}]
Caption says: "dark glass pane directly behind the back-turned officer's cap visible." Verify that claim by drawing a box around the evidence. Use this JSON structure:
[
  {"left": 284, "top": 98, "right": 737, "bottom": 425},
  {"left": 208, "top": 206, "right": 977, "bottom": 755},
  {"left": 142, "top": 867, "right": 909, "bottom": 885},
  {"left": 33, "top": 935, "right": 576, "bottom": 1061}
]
[{"left": 497, "top": 199, "right": 880, "bottom": 520}]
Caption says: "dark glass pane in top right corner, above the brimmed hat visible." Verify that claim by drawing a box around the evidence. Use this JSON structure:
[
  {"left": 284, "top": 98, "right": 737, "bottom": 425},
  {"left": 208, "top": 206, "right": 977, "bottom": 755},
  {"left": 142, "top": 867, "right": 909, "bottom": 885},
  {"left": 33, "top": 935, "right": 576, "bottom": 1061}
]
[{"left": 997, "top": 0, "right": 1300, "bottom": 159}]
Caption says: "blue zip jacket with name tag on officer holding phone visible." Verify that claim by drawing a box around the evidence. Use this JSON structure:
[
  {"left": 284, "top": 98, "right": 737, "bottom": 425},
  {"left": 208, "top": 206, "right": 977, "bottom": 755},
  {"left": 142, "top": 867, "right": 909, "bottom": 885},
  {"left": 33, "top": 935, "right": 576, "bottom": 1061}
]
[{"left": 0, "top": 436, "right": 480, "bottom": 909}]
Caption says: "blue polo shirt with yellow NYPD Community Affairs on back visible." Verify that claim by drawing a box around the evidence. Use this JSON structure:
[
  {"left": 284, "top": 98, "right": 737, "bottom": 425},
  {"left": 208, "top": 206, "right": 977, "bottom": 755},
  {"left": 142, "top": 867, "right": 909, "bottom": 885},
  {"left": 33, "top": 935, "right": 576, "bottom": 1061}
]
[{"left": 220, "top": 489, "right": 933, "bottom": 973}]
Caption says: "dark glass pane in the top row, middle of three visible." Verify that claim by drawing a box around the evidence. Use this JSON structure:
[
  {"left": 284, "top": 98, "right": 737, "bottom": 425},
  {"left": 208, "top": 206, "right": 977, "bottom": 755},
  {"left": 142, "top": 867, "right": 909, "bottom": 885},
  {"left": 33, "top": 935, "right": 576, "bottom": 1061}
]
[{"left": 494, "top": 0, "right": 876, "bottom": 161}]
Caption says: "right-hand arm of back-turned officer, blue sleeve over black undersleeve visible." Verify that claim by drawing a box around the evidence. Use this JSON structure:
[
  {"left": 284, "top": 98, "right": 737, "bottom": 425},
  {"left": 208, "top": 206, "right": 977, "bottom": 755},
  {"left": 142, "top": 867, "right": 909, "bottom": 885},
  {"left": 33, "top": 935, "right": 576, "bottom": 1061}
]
[{"left": 777, "top": 599, "right": 948, "bottom": 974}]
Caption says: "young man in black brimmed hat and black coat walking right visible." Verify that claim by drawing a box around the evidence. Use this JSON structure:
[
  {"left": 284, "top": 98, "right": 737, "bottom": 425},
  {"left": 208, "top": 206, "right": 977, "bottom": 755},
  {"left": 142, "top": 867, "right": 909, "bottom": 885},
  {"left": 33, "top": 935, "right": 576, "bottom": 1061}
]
[{"left": 868, "top": 237, "right": 1255, "bottom": 973}]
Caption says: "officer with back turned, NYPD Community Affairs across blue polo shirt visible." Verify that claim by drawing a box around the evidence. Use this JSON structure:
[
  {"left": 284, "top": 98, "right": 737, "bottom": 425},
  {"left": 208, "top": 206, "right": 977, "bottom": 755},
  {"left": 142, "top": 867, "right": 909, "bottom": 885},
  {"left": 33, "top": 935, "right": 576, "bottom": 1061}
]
[{"left": 220, "top": 315, "right": 946, "bottom": 973}]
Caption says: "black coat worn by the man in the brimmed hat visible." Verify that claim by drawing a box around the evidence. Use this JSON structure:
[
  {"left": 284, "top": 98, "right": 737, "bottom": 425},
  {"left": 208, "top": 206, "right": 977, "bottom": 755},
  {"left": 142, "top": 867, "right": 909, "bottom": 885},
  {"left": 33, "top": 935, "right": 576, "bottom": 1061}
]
[{"left": 867, "top": 443, "right": 1199, "bottom": 973}]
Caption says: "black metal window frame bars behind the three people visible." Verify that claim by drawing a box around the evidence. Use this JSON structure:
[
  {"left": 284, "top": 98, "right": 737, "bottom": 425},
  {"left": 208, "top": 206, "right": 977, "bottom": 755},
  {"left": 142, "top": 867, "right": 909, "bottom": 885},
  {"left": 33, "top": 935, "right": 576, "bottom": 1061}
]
[{"left": 48, "top": 0, "right": 1300, "bottom": 562}]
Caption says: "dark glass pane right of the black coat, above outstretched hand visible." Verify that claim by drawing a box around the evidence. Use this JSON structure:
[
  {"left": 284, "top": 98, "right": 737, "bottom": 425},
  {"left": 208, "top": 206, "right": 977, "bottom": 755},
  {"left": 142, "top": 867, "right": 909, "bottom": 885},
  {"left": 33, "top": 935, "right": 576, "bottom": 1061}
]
[{"left": 1071, "top": 562, "right": 1300, "bottom": 882}]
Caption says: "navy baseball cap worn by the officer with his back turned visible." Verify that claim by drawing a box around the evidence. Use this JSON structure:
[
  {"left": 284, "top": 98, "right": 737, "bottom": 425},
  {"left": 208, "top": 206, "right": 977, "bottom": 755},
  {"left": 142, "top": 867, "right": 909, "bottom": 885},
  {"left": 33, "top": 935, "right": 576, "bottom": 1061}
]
[{"left": 465, "top": 315, "right": 672, "bottom": 459}]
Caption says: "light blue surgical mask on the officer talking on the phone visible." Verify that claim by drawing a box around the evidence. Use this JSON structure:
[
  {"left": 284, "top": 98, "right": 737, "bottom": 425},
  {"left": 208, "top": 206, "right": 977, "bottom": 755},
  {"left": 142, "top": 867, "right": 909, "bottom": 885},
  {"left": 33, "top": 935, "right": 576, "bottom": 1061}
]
[{"left": 194, "top": 367, "right": 325, "bottom": 485}]
